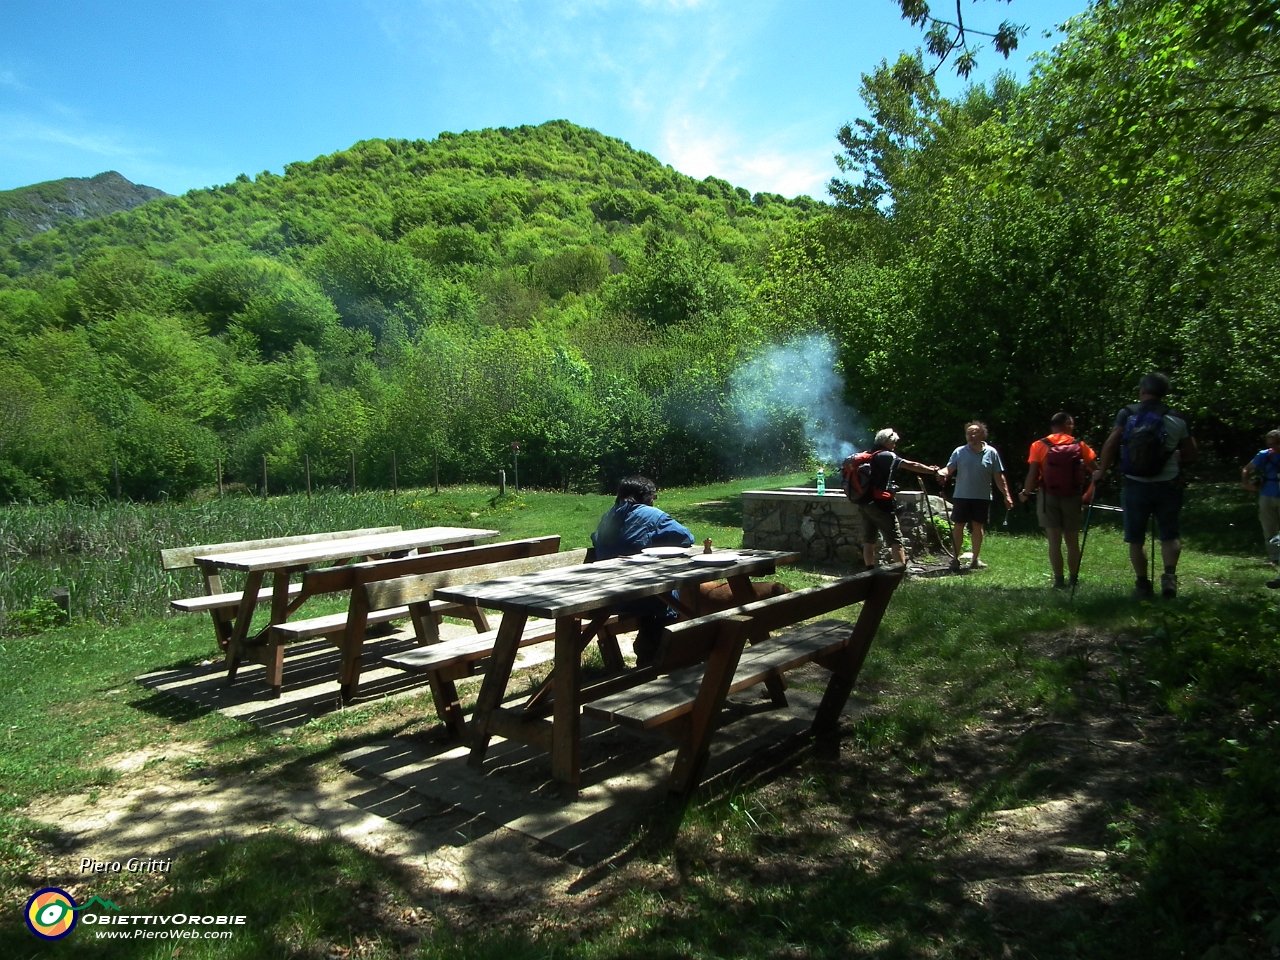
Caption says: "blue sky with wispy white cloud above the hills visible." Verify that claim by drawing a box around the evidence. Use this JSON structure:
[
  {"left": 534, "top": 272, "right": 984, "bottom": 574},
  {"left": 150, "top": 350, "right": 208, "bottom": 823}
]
[{"left": 0, "top": 0, "right": 1087, "bottom": 197}]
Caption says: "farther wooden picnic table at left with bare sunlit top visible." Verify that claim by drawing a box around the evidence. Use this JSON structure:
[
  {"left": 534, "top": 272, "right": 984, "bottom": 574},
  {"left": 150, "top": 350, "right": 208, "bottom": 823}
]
[{"left": 195, "top": 526, "right": 498, "bottom": 687}]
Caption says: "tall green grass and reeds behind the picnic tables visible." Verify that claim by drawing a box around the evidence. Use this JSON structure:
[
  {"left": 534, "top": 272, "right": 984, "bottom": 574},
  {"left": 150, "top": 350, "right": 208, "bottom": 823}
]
[{"left": 0, "top": 476, "right": 797, "bottom": 622}]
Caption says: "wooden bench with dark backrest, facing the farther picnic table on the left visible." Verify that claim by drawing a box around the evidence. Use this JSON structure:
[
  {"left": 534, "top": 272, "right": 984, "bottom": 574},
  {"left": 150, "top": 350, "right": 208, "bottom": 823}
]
[{"left": 238, "top": 536, "right": 559, "bottom": 700}]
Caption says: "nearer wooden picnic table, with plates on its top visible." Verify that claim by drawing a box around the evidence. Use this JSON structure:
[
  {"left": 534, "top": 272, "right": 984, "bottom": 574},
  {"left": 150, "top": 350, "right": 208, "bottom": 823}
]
[{"left": 435, "top": 547, "right": 800, "bottom": 791}]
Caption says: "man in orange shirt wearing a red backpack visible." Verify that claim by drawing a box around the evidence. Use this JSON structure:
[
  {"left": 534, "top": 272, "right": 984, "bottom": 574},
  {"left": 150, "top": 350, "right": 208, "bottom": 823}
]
[{"left": 1018, "top": 413, "right": 1097, "bottom": 590}]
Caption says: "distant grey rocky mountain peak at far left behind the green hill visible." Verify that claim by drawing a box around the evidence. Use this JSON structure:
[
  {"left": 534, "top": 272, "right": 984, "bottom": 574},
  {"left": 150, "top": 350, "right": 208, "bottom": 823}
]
[{"left": 0, "top": 170, "right": 169, "bottom": 239}]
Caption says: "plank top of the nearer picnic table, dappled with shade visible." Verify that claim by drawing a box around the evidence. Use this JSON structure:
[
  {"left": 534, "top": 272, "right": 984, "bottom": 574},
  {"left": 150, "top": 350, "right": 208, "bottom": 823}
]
[{"left": 435, "top": 550, "right": 799, "bottom": 620}]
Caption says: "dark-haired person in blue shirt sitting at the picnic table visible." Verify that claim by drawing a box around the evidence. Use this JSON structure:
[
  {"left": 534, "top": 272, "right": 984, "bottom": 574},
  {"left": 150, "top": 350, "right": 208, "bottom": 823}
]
[{"left": 591, "top": 476, "right": 694, "bottom": 667}]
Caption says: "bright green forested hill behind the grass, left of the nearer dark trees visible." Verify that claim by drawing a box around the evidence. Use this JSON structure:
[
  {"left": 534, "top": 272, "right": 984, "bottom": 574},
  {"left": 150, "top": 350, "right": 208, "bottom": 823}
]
[{"left": 0, "top": 122, "right": 820, "bottom": 498}]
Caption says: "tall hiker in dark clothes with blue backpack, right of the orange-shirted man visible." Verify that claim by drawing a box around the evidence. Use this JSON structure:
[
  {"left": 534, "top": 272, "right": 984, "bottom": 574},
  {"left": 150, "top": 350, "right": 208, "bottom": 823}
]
[{"left": 1093, "top": 372, "right": 1199, "bottom": 600}]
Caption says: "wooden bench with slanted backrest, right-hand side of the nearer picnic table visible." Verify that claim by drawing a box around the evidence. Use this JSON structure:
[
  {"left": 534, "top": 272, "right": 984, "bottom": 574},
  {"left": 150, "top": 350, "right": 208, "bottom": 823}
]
[{"left": 582, "top": 564, "right": 905, "bottom": 794}]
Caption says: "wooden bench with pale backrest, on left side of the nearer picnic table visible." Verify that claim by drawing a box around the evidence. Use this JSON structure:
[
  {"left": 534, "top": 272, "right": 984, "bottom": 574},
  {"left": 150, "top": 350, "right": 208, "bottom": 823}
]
[{"left": 366, "top": 550, "right": 609, "bottom": 739}]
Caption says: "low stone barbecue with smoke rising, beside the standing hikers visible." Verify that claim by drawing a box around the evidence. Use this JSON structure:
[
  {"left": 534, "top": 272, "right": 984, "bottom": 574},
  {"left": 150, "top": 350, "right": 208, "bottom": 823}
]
[{"left": 742, "top": 486, "right": 945, "bottom": 567}]
